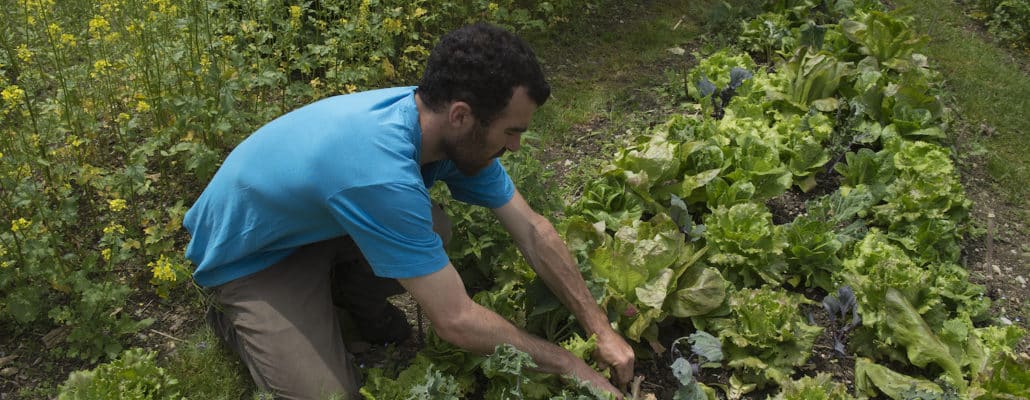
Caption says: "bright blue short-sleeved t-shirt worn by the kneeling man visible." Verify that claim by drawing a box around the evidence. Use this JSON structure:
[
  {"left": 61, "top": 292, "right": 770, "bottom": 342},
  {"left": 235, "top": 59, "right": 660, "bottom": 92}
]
[{"left": 182, "top": 88, "right": 515, "bottom": 287}]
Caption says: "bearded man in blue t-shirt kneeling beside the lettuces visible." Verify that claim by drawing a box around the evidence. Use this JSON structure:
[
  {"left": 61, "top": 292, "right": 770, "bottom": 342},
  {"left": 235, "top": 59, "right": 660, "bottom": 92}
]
[{"left": 183, "top": 24, "right": 633, "bottom": 399}]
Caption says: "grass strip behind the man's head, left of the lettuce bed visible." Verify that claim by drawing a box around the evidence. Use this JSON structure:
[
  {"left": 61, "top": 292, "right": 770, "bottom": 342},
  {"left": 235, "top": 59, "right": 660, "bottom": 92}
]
[{"left": 527, "top": 1, "right": 713, "bottom": 198}]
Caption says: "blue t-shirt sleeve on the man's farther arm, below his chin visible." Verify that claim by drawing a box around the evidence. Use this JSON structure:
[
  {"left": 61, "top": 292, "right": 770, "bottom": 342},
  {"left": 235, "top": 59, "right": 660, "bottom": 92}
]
[{"left": 443, "top": 160, "right": 515, "bottom": 208}]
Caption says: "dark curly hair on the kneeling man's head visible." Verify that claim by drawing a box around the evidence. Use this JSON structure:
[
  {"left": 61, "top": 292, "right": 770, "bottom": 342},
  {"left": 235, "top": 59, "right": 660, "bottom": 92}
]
[{"left": 417, "top": 23, "right": 551, "bottom": 125}]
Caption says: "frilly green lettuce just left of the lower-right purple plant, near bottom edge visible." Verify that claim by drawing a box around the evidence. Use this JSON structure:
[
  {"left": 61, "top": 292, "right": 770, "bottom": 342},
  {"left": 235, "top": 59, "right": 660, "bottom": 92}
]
[{"left": 698, "top": 287, "right": 823, "bottom": 389}]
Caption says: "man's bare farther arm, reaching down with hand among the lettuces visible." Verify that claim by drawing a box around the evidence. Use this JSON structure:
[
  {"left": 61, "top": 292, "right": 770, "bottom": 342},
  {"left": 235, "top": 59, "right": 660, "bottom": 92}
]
[{"left": 494, "top": 192, "right": 634, "bottom": 385}]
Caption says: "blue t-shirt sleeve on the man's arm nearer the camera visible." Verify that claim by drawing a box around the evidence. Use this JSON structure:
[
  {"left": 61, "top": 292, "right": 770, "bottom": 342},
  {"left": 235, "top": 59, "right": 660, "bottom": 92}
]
[{"left": 329, "top": 184, "right": 449, "bottom": 278}]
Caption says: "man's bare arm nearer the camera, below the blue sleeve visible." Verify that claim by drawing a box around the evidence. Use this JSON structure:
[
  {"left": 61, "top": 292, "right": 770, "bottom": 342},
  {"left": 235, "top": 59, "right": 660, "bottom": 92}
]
[{"left": 400, "top": 264, "right": 619, "bottom": 394}]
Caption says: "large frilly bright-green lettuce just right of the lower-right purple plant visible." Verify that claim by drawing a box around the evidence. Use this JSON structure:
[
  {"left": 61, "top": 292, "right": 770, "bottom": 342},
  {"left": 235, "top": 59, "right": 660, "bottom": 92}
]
[{"left": 840, "top": 230, "right": 1006, "bottom": 393}]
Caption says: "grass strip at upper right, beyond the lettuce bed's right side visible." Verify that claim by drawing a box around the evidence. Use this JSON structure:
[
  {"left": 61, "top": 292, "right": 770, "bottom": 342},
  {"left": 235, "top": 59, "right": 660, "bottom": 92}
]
[{"left": 895, "top": 0, "right": 1030, "bottom": 223}]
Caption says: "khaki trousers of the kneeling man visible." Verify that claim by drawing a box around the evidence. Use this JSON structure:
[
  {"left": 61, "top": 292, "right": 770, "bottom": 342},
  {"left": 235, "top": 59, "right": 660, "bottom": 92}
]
[{"left": 208, "top": 206, "right": 450, "bottom": 399}]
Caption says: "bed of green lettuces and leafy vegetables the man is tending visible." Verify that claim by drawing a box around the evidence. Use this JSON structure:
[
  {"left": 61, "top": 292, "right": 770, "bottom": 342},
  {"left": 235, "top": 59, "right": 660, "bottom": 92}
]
[{"left": 363, "top": 0, "right": 1030, "bottom": 399}]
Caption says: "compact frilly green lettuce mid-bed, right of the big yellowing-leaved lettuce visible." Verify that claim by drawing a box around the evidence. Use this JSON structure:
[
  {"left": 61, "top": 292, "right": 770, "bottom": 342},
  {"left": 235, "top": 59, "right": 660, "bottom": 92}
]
[{"left": 705, "top": 203, "right": 788, "bottom": 288}]
